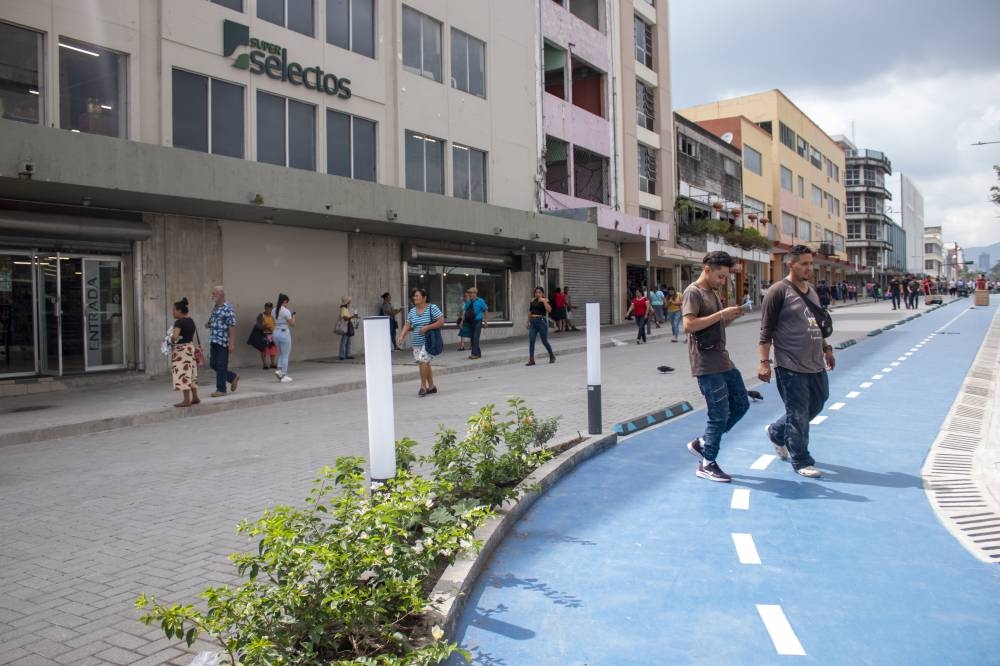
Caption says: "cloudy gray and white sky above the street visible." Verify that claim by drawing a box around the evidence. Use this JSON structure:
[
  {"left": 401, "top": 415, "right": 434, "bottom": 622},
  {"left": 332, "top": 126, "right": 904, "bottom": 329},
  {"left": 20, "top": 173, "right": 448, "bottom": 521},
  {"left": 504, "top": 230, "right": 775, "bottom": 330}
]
[{"left": 670, "top": 0, "right": 1000, "bottom": 247}]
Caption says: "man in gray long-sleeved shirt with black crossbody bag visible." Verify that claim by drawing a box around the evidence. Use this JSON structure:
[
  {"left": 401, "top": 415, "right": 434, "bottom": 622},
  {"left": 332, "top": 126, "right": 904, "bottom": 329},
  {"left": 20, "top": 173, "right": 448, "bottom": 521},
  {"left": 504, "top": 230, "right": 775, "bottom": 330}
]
[{"left": 757, "top": 245, "right": 835, "bottom": 478}]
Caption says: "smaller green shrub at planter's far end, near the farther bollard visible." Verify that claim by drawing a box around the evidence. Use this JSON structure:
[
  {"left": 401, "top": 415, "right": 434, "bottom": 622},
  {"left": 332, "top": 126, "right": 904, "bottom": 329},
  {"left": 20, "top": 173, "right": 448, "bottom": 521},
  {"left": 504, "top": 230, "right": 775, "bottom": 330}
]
[{"left": 420, "top": 398, "right": 559, "bottom": 506}]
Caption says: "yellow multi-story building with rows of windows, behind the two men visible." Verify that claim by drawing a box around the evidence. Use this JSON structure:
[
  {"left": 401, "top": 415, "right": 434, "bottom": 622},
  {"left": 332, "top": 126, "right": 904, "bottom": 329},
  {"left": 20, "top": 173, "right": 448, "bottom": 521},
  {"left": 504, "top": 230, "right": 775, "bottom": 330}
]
[{"left": 678, "top": 90, "right": 850, "bottom": 283}]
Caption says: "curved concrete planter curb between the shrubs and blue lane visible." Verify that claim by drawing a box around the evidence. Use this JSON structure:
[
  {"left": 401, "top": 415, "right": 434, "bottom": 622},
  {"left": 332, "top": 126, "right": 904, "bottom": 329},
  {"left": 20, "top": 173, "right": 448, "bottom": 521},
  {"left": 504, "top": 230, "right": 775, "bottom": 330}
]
[{"left": 423, "top": 433, "right": 618, "bottom": 639}]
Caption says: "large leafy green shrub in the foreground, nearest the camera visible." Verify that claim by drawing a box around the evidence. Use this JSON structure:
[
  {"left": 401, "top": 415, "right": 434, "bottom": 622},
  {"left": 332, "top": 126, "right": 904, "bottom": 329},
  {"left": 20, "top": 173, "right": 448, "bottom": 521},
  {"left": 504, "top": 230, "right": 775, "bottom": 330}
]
[{"left": 136, "top": 458, "right": 489, "bottom": 666}]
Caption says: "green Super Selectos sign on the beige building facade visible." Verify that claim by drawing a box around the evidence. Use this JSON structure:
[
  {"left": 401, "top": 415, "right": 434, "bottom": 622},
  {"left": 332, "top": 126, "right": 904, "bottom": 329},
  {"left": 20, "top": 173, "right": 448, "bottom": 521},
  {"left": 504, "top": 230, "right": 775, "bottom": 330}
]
[{"left": 222, "top": 19, "right": 351, "bottom": 99}]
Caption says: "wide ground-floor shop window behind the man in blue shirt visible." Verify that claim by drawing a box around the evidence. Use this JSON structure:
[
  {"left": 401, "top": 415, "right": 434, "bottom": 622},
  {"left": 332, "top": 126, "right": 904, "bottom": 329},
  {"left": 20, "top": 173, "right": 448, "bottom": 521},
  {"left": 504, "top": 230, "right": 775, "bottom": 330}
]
[{"left": 407, "top": 264, "right": 510, "bottom": 321}]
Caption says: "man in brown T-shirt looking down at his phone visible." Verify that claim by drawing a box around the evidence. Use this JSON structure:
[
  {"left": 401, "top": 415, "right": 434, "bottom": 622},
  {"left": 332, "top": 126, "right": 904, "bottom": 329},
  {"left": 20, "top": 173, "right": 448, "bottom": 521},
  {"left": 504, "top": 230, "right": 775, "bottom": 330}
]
[{"left": 681, "top": 251, "right": 750, "bottom": 483}]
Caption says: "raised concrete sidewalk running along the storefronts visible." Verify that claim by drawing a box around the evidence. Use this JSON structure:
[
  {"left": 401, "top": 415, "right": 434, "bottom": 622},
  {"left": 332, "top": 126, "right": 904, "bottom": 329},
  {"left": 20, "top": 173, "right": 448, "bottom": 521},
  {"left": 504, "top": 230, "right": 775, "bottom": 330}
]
[{"left": 0, "top": 302, "right": 892, "bottom": 446}]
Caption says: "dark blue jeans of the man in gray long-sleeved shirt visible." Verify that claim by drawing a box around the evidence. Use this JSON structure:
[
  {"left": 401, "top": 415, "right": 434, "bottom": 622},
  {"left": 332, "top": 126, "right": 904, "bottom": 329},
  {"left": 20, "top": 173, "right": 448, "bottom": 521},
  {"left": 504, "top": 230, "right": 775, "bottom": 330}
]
[{"left": 770, "top": 368, "right": 830, "bottom": 469}]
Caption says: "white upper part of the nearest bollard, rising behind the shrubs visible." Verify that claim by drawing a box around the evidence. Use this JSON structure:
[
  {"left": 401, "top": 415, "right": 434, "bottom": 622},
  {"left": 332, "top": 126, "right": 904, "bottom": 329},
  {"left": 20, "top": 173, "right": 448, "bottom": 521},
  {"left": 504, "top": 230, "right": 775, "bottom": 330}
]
[{"left": 363, "top": 317, "right": 396, "bottom": 482}]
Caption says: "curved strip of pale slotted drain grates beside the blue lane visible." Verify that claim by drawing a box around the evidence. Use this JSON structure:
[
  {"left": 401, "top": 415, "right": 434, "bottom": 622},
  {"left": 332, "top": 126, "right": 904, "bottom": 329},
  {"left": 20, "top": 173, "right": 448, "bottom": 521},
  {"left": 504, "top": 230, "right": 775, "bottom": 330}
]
[{"left": 922, "top": 304, "right": 1000, "bottom": 563}]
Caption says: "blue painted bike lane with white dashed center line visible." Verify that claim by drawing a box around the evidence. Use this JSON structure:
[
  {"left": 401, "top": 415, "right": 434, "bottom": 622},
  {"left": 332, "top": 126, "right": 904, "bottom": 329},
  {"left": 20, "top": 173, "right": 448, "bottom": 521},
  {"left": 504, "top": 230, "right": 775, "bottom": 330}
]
[{"left": 450, "top": 301, "right": 1000, "bottom": 666}]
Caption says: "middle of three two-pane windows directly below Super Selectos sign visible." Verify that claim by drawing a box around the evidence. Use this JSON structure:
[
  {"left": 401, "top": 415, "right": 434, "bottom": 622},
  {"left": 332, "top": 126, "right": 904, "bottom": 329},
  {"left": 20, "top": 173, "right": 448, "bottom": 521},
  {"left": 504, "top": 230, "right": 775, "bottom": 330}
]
[{"left": 257, "top": 90, "right": 316, "bottom": 171}]
